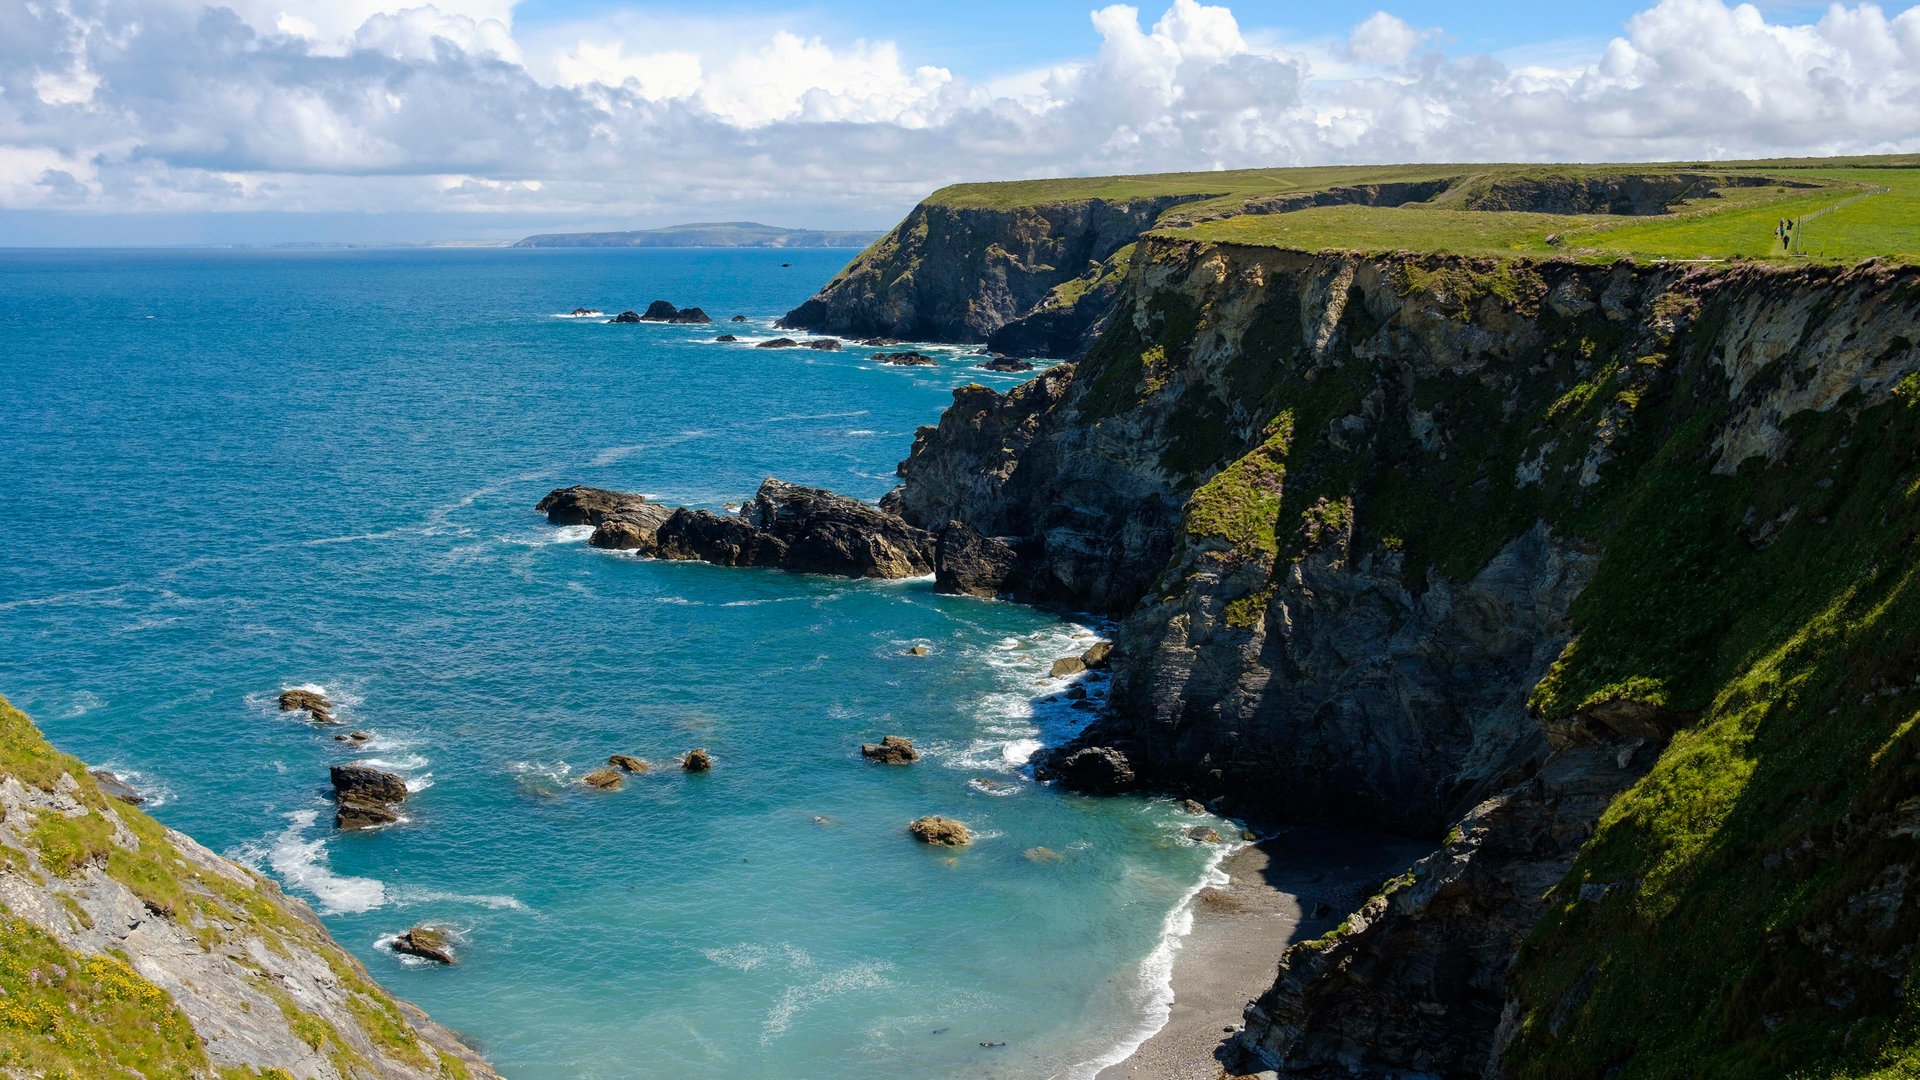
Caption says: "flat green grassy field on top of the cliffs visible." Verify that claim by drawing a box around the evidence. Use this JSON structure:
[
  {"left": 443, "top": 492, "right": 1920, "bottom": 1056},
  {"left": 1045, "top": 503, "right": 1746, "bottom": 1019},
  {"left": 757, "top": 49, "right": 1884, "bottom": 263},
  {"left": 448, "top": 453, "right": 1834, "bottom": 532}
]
[{"left": 927, "top": 156, "right": 1920, "bottom": 261}]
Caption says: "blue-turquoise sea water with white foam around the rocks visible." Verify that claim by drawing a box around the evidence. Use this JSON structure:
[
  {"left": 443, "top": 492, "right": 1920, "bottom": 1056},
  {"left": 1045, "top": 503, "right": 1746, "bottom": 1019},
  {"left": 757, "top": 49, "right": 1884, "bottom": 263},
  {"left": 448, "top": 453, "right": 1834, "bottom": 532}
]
[{"left": 0, "top": 250, "right": 1215, "bottom": 1080}]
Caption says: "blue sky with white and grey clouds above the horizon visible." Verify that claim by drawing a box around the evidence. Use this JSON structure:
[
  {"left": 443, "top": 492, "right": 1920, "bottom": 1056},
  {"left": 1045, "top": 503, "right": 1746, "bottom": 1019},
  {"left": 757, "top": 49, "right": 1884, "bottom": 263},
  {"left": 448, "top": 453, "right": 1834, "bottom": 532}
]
[{"left": 0, "top": 0, "right": 1920, "bottom": 246}]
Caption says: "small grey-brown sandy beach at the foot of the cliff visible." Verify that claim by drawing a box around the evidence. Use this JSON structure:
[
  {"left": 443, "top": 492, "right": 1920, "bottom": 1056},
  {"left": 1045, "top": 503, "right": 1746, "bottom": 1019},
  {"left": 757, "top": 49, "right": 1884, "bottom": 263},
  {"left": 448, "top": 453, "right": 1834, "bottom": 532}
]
[{"left": 1100, "top": 828, "right": 1432, "bottom": 1080}]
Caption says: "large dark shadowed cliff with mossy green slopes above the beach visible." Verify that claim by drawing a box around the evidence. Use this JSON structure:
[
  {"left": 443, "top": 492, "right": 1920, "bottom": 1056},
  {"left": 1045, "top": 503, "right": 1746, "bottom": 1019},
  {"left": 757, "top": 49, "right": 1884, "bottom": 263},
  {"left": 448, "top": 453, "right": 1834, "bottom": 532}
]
[{"left": 887, "top": 236, "right": 1920, "bottom": 1078}]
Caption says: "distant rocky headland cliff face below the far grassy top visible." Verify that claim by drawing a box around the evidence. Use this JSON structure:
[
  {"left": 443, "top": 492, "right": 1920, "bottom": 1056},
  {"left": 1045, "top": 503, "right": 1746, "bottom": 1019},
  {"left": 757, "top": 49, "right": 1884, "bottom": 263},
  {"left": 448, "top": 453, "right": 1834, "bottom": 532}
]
[{"left": 780, "top": 196, "right": 1204, "bottom": 343}]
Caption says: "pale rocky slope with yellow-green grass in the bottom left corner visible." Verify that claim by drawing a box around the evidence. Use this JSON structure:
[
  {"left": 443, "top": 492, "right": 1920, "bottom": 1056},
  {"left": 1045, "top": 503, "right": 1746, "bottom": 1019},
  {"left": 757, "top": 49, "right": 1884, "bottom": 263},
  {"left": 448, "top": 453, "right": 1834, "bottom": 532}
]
[{"left": 0, "top": 700, "right": 493, "bottom": 1080}]
